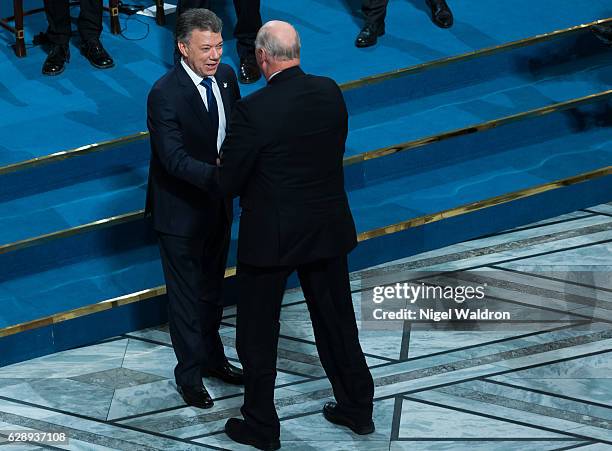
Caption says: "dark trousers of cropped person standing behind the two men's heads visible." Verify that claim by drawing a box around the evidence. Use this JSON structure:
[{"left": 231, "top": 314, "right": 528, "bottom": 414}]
[{"left": 177, "top": 0, "right": 261, "bottom": 58}]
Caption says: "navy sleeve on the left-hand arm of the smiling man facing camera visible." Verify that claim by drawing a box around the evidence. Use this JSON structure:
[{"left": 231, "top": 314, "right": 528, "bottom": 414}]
[{"left": 147, "top": 89, "right": 217, "bottom": 191}]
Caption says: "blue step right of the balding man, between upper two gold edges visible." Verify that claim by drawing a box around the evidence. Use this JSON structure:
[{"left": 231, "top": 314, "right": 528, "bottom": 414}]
[{"left": 345, "top": 30, "right": 612, "bottom": 156}]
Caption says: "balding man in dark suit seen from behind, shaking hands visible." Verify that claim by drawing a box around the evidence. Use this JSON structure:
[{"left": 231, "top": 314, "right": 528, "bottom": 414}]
[{"left": 219, "top": 21, "right": 374, "bottom": 449}]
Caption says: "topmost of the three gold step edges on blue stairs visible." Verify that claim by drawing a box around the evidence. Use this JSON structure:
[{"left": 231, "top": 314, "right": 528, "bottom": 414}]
[{"left": 0, "top": 17, "right": 612, "bottom": 175}]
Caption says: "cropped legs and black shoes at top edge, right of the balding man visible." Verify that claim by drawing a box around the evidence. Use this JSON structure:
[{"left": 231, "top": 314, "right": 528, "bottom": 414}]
[{"left": 355, "top": 0, "right": 453, "bottom": 47}]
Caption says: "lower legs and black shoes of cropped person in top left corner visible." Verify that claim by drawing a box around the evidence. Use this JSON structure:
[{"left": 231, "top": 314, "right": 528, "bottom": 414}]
[{"left": 42, "top": 0, "right": 115, "bottom": 75}]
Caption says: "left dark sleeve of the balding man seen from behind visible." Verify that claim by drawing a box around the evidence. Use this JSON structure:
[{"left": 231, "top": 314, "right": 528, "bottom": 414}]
[{"left": 219, "top": 101, "right": 259, "bottom": 197}]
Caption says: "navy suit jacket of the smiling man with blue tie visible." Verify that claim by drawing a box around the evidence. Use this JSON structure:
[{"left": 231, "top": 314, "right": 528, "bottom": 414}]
[{"left": 145, "top": 63, "right": 240, "bottom": 237}]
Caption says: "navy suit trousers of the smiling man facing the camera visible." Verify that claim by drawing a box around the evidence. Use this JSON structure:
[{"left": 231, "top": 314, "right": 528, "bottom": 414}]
[{"left": 158, "top": 214, "right": 230, "bottom": 386}]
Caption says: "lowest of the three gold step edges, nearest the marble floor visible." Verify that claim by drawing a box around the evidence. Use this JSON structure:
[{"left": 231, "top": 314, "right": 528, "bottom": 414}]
[{"left": 0, "top": 166, "right": 612, "bottom": 338}]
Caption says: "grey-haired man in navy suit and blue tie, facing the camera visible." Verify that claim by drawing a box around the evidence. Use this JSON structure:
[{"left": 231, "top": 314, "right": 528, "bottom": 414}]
[{"left": 146, "top": 9, "right": 242, "bottom": 408}]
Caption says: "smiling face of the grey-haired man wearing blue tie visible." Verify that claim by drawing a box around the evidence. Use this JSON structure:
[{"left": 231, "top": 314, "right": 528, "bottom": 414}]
[{"left": 178, "top": 30, "right": 223, "bottom": 77}]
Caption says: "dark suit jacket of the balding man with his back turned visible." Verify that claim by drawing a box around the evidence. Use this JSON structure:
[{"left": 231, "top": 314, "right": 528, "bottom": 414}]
[{"left": 219, "top": 67, "right": 357, "bottom": 266}]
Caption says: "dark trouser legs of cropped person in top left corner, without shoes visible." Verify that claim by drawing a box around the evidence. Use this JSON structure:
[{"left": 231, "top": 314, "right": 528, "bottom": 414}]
[{"left": 45, "top": 0, "right": 102, "bottom": 44}]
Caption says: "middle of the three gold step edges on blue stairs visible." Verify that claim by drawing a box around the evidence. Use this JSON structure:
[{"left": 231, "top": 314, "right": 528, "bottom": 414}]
[{"left": 0, "top": 89, "right": 612, "bottom": 255}]
